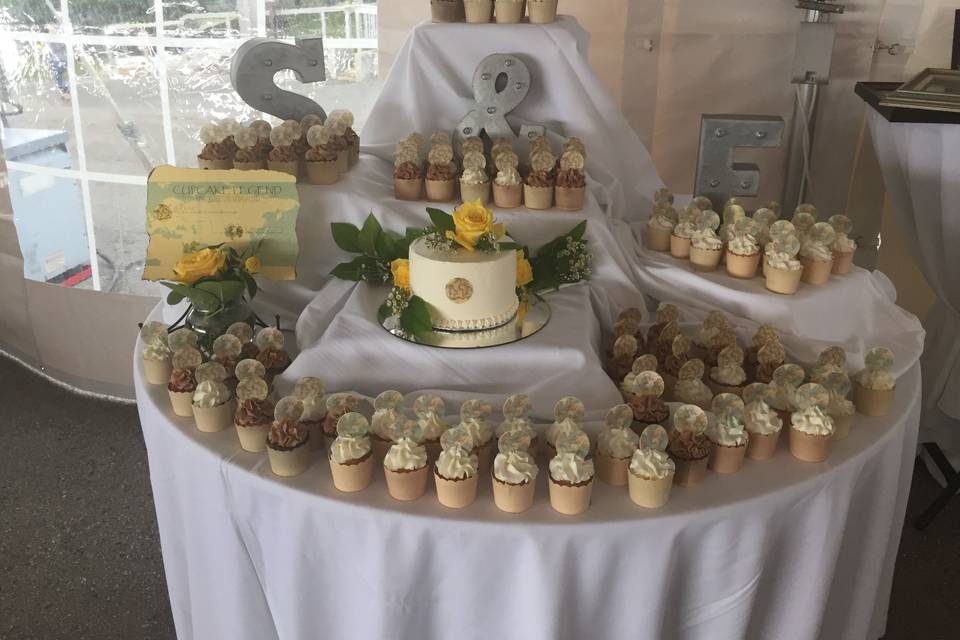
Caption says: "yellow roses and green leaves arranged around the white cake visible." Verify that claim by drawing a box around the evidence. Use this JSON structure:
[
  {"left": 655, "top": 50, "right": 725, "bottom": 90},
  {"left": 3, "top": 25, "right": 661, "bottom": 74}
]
[{"left": 330, "top": 200, "right": 593, "bottom": 338}]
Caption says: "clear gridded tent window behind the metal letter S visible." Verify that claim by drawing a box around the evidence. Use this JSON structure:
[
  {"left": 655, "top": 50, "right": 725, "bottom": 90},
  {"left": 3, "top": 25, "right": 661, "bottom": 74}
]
[{"left": 0, "top": 0, "right": 379, "bottom": 295}]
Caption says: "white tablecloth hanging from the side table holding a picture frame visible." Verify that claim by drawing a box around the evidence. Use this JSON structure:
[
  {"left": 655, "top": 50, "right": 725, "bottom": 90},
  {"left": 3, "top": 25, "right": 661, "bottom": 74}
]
[{"left": 870, "top": 111, "right": 960, "bottom": 455}]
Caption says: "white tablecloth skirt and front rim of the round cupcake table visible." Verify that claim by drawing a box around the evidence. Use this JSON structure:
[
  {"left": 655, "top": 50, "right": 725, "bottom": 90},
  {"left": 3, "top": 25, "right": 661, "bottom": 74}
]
[{"left": 134, "top": 340, "right": 920, "bottom": 640}]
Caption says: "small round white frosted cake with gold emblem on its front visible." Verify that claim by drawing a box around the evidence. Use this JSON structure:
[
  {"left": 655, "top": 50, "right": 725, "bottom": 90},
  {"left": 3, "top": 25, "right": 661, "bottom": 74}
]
[{"left": 410, "top": 238, "right": 519, "bottom": 331}]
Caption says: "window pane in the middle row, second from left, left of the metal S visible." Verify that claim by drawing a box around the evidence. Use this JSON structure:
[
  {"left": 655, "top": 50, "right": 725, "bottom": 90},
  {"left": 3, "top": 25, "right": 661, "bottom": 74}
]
[{"left": 76, "top": 46, "right": 167, "bottom": 176}]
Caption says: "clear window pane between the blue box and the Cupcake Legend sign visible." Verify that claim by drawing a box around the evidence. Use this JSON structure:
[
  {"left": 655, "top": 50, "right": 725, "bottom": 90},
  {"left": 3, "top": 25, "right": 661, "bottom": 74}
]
[{"left": 90, "top": 182, "right": 164, "bottom": 296}]
